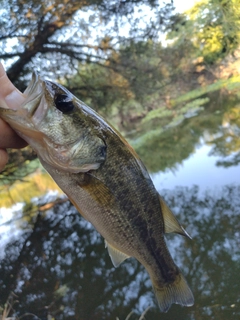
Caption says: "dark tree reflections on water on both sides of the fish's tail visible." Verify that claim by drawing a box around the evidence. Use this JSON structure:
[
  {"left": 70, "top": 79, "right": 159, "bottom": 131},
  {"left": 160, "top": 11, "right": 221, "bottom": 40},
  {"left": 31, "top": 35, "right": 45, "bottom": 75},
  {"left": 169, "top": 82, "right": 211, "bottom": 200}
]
[{"left": 0, "top": 186, "right": 240, "bottom": 320}]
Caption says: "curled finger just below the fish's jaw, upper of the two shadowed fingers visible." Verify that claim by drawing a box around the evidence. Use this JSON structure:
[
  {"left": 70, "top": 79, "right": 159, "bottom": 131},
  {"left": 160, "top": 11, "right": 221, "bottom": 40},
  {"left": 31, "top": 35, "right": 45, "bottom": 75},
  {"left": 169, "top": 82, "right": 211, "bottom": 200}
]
[{"left": 0, "top": 119, "right": 27, "bottom": 149}]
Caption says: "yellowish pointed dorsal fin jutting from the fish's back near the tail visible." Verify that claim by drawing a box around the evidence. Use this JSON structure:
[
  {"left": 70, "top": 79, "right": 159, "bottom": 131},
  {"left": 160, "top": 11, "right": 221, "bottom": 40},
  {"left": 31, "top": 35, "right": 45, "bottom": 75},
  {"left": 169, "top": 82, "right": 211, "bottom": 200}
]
[{"left": 159, "top": 196, "right": 192, "bottom": 239}]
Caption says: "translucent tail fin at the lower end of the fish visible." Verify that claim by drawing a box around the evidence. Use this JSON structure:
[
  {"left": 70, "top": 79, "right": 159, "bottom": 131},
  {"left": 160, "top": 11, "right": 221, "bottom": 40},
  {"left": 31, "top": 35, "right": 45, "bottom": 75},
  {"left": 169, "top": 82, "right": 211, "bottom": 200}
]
[{"left": 152, "top": 273, "right": 194, "bottom": 312}]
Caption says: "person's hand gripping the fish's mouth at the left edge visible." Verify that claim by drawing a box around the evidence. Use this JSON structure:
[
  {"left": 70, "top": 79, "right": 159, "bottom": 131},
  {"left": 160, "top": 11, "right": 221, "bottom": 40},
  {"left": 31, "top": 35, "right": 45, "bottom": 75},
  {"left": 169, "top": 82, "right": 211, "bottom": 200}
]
[{"left": 0, "top": 62, "right": 27, "bottom": 172}]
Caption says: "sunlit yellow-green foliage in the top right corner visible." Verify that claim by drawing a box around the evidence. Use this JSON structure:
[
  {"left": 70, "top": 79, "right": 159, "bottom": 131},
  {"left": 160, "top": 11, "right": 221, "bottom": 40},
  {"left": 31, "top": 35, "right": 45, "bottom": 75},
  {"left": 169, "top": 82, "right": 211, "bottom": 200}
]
[{"left": 168, "top": 0, "right": 240, "bottom": 64}]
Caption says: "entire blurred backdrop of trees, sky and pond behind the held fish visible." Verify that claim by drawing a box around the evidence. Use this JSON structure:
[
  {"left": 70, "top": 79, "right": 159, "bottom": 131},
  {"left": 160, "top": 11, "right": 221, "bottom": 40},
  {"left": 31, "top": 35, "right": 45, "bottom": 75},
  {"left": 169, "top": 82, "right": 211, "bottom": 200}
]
[{"left": 0, "top": 0, "right": 240, "bottom": 320}]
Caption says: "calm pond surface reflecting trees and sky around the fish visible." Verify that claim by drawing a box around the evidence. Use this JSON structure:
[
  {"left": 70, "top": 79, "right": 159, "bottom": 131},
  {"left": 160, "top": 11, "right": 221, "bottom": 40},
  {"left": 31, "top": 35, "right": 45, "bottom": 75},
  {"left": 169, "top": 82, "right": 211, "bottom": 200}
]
[{"left": 0, "top": 91, "right": 240, "bottom": 320}]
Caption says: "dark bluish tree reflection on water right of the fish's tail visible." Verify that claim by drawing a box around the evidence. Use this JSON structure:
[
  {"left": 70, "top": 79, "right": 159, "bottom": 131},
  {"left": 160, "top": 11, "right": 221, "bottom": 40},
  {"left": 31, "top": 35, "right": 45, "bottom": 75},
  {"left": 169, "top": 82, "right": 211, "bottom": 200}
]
[{"left": 156, "top": 186, "right": 240, "bottom": 319}]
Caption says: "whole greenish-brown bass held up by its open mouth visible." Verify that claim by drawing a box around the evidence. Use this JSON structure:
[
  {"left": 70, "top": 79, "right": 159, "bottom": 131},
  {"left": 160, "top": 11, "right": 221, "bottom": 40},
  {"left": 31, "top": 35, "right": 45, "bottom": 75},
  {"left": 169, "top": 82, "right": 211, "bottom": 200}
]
[{"left": 0, "top": 72, "right": 194, "bottom": 312}]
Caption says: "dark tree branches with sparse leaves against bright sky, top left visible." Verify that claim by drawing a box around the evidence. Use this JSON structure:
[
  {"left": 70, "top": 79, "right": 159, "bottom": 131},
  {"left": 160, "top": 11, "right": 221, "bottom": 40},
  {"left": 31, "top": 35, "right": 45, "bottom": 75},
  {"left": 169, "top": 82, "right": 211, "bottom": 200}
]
[{"left": 0, "top": 0, "right": 173, "bottom": 90}]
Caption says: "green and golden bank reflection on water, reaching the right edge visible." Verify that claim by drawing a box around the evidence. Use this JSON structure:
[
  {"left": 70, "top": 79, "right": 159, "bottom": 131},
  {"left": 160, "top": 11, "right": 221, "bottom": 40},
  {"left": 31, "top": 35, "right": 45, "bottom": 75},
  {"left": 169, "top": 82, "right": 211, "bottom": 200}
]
[{"left": 131, "top": 93, "right": 240, "bottom": 173}]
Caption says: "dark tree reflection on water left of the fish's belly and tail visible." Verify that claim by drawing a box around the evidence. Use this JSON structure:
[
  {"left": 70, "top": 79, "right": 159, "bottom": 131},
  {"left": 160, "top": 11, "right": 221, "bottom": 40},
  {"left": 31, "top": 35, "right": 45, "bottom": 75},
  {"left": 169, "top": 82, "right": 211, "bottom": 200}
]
[{"left": 0, "top": 199, "right": 149, "bottom": 319}]
